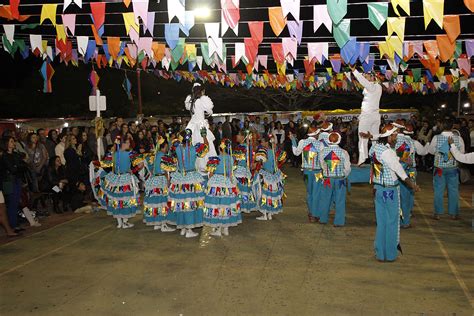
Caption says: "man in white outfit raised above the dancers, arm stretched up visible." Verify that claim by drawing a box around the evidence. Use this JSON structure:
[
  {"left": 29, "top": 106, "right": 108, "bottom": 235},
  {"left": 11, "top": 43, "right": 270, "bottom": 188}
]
[{"left": 352, "top": 69, "right": 382, "bottom": 165}]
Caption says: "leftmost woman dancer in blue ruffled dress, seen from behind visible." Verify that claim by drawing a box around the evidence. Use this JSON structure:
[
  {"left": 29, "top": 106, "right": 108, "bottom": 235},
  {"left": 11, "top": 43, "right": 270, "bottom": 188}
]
[{"left": 102, "top": 137, "right": 143, "bottom": 228}]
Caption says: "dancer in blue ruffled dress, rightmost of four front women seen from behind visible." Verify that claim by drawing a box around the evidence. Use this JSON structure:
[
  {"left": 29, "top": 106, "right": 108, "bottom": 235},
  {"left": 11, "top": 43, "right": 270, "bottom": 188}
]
[{"left": 204, "top": 139, "right": 242, "bottom": 236}]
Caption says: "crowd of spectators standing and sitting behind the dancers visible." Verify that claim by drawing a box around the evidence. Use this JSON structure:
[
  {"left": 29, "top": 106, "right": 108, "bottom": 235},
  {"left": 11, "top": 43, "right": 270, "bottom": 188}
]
[{"left": 0, "top": 115, "right": 474, "bottom": 235}]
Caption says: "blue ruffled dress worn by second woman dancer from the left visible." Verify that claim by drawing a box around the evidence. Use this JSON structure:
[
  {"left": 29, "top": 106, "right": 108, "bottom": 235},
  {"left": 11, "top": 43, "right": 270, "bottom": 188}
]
[{"left": 143, "top": 151, "right": 176, "bottom": 226}]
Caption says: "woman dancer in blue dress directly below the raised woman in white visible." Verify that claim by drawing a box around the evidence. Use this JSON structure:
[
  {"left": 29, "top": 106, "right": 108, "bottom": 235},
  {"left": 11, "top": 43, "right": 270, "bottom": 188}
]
[{"left": 169, "top": 129, "right": 208, "bottom": 238}]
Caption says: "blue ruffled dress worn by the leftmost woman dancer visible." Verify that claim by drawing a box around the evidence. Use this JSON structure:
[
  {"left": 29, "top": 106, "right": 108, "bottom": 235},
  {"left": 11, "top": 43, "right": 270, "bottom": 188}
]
[{"left": 101, "top": 151, "right": 138, "bottom": 218}]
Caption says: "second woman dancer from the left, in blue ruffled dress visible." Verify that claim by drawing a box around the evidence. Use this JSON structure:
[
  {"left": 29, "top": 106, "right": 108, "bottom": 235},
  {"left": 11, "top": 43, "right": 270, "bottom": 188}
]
[{"left": 143, "top": 137, "right": 176, "bottom": 232}]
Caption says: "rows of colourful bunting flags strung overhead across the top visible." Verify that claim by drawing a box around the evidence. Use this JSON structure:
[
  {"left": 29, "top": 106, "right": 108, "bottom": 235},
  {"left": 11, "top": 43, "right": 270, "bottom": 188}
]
[{"left": 0, "top": 0, "right": 474, "bottom": 94}]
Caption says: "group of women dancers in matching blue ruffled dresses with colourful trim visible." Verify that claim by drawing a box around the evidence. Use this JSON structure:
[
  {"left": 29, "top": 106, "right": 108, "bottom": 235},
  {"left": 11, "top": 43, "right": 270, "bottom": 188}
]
[{"left": 91, "top": 128, "right": 286, "bottom": 238}]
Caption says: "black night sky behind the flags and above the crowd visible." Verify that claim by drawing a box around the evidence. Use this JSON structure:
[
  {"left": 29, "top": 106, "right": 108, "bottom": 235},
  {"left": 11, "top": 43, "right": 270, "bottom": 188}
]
[{"left": 0, "top": 0, "right": 474, "bottom": 117}]
